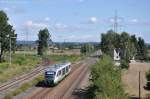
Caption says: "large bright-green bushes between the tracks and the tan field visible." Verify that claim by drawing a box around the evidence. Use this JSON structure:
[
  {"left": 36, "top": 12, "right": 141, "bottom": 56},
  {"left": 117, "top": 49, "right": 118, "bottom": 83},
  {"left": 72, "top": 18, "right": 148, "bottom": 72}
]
[{"left": 88, "top": 55, "right": 128, "bottom": 99}]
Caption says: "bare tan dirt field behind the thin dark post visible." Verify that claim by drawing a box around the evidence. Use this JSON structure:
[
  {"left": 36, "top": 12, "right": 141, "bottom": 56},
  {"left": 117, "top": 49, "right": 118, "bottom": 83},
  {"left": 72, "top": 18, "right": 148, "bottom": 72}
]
[{"left": 122, "top": 62, "right": 150, "bottom": 98}]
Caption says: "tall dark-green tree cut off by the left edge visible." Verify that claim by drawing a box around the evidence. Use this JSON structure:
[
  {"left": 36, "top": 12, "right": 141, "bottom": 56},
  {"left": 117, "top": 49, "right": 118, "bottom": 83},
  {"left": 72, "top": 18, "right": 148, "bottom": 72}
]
[{"left": 0, "top": 11, "right": 17, "bottom": 62}]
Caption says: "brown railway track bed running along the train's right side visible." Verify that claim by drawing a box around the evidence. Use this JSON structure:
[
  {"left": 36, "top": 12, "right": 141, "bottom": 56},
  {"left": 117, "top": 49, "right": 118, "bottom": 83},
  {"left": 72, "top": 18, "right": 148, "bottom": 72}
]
[{"left": 22, "top": 59, "right": 96, "bottom": 99}]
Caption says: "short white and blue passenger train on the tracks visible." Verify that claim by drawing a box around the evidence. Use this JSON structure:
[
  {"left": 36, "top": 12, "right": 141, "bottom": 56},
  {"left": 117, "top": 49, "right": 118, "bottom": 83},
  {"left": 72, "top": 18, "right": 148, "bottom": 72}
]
[{"left": 45, "top": 62, "right": 71, "bottom": 86}]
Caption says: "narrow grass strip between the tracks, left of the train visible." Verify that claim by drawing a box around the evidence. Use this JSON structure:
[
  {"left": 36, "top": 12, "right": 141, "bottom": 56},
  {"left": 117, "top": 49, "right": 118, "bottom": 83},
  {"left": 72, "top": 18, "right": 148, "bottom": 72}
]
[{"left": 4, "top": 75, "right": 44, "bottom": 99}]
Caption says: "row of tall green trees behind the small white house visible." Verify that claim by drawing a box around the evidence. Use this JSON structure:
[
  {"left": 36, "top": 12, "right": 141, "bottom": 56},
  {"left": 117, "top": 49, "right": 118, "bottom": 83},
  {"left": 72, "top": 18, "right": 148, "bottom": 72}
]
[{"left": 100, "top": 30, "right": 147, "bottom": 61}]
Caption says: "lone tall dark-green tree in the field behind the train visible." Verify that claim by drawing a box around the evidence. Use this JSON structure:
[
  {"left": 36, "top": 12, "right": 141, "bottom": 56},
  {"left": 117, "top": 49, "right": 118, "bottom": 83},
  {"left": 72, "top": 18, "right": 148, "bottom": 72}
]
[{"left": 37, "top": 28, "right": 51, "bottom": 55}]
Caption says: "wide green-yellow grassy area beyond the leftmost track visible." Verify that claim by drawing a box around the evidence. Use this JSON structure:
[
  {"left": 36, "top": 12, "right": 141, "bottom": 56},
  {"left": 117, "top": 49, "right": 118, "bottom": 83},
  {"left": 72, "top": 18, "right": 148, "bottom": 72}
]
[{"left": 0, "top": 54, "right": 41, "bottom": 83}]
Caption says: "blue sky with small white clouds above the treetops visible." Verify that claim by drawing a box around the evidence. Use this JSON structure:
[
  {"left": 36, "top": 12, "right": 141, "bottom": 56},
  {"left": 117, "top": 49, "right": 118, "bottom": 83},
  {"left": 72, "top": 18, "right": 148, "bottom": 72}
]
[{"left": 0, "top": 0, "right": 150, "bottom": 43}]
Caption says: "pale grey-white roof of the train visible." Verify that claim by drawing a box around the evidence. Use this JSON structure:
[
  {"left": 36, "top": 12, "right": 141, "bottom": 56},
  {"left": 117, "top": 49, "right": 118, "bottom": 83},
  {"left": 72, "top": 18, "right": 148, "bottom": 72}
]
[{"left": 45, "top": 62, "right": 71, "bottom": 71}]
